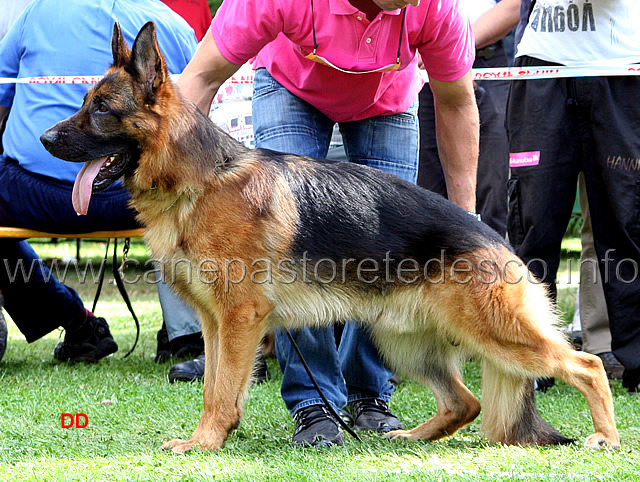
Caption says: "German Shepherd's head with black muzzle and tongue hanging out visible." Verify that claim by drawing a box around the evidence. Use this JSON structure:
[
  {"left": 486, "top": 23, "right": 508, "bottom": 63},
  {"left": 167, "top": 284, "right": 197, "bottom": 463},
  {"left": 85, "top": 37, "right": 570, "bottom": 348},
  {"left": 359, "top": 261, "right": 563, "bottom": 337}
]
[{"left": 40, "top": 22, "right": 171, "bottom": 214}]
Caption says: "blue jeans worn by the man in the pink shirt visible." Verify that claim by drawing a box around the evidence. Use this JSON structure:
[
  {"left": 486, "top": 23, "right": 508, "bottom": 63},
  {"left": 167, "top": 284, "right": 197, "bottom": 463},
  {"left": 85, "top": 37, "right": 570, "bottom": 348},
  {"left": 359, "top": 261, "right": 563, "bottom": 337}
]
[{"left": 253, "top": 69, "right": 419, "bottom": 414}]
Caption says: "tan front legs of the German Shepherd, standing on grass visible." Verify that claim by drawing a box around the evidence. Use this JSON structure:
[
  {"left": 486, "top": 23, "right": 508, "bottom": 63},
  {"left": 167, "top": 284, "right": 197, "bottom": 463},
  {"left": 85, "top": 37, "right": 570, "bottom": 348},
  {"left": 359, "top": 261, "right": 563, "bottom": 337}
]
[{"left": 163, "top": 303, "right": 268, "bottom": 453}]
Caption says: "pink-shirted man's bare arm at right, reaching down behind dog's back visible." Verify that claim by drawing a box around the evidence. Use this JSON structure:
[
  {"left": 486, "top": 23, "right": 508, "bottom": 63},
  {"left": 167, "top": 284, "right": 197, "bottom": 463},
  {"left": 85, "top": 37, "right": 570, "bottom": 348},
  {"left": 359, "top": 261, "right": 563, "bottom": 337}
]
[{"left": 429, "top": 71, "right": 480, "bottom": 212}]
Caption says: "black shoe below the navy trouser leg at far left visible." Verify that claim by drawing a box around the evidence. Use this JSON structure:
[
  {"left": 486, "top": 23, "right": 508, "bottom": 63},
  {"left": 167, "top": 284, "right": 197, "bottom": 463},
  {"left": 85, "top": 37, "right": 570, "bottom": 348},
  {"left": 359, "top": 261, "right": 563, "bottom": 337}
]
[{"left": 53, "top": 315, "right": 118, "bottom": 362}]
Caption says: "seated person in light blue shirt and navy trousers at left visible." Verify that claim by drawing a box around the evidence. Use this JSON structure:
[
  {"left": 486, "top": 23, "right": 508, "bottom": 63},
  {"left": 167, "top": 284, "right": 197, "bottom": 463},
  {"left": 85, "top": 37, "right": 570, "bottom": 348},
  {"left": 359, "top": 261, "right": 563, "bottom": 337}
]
[{"left": 0, "top": 0, "right": 199, "bottom": 362}]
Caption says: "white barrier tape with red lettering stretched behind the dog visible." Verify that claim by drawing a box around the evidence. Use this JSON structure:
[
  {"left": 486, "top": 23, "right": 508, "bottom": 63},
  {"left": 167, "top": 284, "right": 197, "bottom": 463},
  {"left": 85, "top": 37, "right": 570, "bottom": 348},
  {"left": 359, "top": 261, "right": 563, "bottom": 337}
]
[{"left": 0, "top": 64, "right": 640, "bottom": 84}]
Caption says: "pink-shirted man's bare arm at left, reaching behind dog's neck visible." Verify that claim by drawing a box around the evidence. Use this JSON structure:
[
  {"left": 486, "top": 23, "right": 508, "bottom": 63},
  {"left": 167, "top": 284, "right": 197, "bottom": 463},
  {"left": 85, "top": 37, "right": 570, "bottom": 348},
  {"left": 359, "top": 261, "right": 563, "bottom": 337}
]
[{"left": 177, "top": 32, "right": 241, "bottom": 115}]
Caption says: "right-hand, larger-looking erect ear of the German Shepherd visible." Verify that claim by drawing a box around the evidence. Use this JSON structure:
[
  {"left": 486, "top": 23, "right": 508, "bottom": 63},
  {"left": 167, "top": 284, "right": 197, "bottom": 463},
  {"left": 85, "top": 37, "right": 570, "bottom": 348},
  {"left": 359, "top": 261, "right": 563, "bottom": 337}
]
[{"left": 125, "top": 22, "right": 169, "bottom": 96}]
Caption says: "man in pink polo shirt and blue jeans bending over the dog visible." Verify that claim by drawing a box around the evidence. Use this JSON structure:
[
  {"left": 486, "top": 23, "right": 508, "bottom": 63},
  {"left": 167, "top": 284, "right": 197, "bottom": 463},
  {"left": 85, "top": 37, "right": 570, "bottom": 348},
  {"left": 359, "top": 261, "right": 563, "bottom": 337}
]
[{"left": 178, "top": 0, "right": 478, "bottom": 446}]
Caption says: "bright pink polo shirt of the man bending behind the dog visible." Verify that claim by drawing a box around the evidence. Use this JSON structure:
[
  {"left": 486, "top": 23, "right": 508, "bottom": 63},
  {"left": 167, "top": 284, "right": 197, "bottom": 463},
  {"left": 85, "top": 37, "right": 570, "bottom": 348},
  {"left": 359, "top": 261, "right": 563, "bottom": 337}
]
[{"left": 211, "top": 0, "right": 475, "bottom": 122}]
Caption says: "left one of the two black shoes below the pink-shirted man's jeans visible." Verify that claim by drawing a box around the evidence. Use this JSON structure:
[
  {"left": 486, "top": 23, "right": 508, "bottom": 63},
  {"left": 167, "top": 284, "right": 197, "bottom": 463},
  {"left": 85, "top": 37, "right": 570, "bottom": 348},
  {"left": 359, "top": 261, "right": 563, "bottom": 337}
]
[{"left": 291, "top": 405, "right": 344, "bottom": 447}]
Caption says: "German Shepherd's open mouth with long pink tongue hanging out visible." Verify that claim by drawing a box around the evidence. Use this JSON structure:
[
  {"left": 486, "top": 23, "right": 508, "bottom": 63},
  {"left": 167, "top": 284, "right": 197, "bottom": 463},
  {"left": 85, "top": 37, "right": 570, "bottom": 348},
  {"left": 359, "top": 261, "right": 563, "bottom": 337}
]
[{"left": 72, "top": 153, "right": 129, "bottom": 215}]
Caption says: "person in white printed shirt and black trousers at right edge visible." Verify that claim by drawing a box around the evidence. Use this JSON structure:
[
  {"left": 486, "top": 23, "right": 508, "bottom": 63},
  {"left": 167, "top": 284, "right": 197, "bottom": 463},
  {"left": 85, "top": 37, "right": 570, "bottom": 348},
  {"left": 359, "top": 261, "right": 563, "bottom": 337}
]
[{"left": 507, "top": 0, "right": 640, "bottom": 391}]
